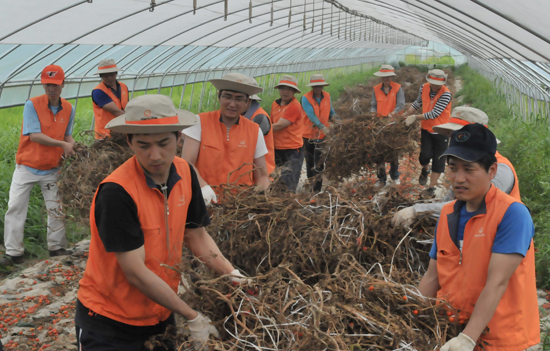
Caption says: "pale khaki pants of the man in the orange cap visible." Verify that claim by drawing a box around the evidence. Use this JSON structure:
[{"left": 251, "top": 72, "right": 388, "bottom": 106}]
[{"left": 4, "top": 165, "right": 67, "bottom": 256}]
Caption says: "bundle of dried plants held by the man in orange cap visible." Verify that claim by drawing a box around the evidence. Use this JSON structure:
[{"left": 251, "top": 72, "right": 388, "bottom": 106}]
[{"left": 58, "top": 131, "right": 133, "bottom": 224}]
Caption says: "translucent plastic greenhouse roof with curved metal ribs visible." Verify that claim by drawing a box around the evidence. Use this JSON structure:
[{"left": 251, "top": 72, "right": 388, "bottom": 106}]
[{"left": 0, "top": 0, "right": 550, "bottom": 106}]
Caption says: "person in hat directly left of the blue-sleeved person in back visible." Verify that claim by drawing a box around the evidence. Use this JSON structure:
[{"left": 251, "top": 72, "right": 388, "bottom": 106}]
[{"left": 271, "top": 75, "right": 304, "bottom": 192}]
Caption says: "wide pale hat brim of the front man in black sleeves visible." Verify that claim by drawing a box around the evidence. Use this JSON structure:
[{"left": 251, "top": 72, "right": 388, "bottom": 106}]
[{"left": 105, "top": 109, "right": 199, "bottom": 134}]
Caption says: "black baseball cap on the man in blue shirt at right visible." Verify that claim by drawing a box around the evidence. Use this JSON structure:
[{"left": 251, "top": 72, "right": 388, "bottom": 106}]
[{"left": 441, "top": 123, "right": 497, "bottom": 162}]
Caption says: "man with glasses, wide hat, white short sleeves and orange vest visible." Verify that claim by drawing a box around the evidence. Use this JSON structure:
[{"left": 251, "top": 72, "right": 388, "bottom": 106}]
[{"left": 182, "top": 73, "right": 270, "bottom": 205}]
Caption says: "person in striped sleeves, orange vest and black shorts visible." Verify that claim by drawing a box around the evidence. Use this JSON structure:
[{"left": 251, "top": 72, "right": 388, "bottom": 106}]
[{"left": 403, "top": 69, "right": 452, "bottom": 197}]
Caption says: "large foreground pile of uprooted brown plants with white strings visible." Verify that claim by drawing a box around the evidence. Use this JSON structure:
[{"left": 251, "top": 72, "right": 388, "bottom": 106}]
[{"left": 143, "top": 185, "right": 461, "bottom": 350}]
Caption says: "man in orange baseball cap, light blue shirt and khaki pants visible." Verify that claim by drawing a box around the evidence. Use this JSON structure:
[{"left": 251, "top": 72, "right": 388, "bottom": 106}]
[{"left": 0, "top": 65, "right": 75, "bottom": 266}]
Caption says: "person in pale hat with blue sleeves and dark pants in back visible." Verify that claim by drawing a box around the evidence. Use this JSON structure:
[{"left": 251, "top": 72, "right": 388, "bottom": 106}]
[{"left": 302, "top": 74, "right": 336, "bottom": 192}]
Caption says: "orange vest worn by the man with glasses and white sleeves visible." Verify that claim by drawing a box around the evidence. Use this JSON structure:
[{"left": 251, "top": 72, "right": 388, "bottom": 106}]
[{"left": 195, "top": 110, "right": 260, "bottom": 190}]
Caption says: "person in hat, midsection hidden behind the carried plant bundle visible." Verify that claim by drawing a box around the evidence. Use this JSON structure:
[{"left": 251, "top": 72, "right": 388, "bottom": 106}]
[{"left": 371, "top": 65, "right": 405, "bottom": 186}]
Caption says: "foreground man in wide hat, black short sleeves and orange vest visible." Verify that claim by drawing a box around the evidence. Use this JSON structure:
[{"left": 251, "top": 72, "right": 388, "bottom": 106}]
[{"left": 75, "top": 94, "right": 248, "bottom": 351}]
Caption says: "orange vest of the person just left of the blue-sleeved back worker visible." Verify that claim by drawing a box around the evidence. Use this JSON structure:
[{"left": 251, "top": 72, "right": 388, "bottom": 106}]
[{"left": 271, "top": 98, "right": 304, "bottom": 150}]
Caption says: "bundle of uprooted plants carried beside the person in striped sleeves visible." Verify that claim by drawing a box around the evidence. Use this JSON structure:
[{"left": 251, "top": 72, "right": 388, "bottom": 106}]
[{"left": 322, "top": 115, "right": 420, "bottom": 180}]
